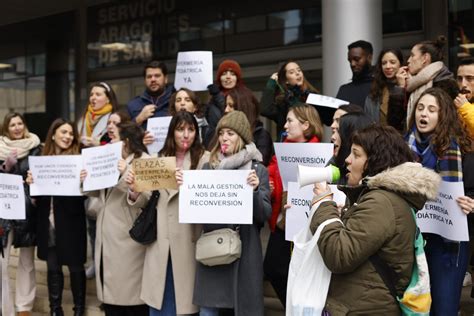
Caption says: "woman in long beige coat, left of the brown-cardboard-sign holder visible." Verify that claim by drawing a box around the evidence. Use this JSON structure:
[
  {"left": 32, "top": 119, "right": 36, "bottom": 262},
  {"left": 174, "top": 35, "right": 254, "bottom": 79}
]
[{"left": 82, "top": 122, "right": 150, "bottom": 316}]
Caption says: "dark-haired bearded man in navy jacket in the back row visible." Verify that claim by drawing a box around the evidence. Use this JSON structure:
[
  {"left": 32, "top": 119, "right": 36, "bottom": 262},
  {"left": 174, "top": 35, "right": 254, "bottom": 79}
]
[{"left": 127, "top": 60, "right": 174, "bottom": 129}]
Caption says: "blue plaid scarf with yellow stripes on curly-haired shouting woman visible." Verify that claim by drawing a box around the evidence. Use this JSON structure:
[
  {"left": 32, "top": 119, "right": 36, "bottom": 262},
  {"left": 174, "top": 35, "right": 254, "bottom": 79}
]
[{"left": 407, "top": 126, "right": 462, "bottom": 182}]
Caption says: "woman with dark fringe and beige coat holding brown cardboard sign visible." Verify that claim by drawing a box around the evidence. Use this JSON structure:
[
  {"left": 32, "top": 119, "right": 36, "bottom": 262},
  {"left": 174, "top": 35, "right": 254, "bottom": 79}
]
[{"left": 127, "top": 112, "right": 209, "bottom": 316}]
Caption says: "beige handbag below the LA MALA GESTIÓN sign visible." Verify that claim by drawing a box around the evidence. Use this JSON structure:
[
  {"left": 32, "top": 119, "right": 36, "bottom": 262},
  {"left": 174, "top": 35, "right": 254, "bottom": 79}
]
[{"left": 196, "top": 226, "right": 242, "bottom": 267}]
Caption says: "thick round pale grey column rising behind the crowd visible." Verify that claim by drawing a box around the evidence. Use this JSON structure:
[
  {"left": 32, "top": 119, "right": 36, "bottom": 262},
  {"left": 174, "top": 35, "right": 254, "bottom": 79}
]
[{"left": 322, "top": 0, "right": 382, "bottom": 96}]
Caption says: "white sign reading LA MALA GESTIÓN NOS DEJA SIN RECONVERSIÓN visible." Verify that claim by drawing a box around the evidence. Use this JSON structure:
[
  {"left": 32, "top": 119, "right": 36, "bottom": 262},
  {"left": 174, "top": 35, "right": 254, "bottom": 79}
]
[{"left": 179, "top": 170, "right": 253, "bottom": 224}]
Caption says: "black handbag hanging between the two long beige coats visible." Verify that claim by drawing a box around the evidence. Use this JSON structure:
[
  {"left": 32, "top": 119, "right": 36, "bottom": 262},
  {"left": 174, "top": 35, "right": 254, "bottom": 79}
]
[{"left": 129, "top": 191, "right": 160, "bottom": 245}]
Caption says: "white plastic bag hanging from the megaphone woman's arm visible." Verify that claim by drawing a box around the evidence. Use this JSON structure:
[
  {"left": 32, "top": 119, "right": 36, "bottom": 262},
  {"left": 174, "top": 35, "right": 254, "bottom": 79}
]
[{"left": 286, "top": 218, "right": 342, "bottom": 316}]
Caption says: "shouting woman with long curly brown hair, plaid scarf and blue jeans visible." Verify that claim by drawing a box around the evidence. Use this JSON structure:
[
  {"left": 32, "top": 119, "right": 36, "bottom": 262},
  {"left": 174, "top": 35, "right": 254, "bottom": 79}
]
[{"left": 407, "top": 88, "right": 474, "bottom": 315}]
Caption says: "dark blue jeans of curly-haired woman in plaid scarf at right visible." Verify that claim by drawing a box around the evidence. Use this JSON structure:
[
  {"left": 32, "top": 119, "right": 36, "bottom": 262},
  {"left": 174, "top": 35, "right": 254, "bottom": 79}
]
[{"left": 425, "top": 234, "right": 469, "bottom": 316}]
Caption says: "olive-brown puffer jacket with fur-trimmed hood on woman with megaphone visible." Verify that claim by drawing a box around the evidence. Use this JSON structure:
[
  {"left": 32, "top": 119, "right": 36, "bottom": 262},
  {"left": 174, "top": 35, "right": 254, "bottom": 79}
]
[{"left": 311, "top": 163, "right": 440, "bottom": 316}]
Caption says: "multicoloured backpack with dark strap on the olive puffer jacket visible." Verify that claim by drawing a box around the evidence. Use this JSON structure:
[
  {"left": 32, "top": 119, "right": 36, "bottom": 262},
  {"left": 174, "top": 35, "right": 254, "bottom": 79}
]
[{"left": 370, "top": 208, "right": 431, "bottom": 316}]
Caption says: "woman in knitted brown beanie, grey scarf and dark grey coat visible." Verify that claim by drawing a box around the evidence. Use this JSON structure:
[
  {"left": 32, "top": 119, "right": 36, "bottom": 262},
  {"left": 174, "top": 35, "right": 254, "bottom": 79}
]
[{"left": 193, "top": 111, "right": 271, "bottom": 316}]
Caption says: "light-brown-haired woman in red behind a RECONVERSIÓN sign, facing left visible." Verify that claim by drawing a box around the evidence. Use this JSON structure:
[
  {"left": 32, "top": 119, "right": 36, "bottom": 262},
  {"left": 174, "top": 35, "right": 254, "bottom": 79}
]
[{"left": 264, "top": 104, "right": 323, "bottom": 306}]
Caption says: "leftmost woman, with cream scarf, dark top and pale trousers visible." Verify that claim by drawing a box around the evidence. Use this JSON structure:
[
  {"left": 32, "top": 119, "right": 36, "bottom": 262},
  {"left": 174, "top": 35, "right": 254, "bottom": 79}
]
[{"left": 0, "top": 113, "right": 41, "bottom": 315}]
